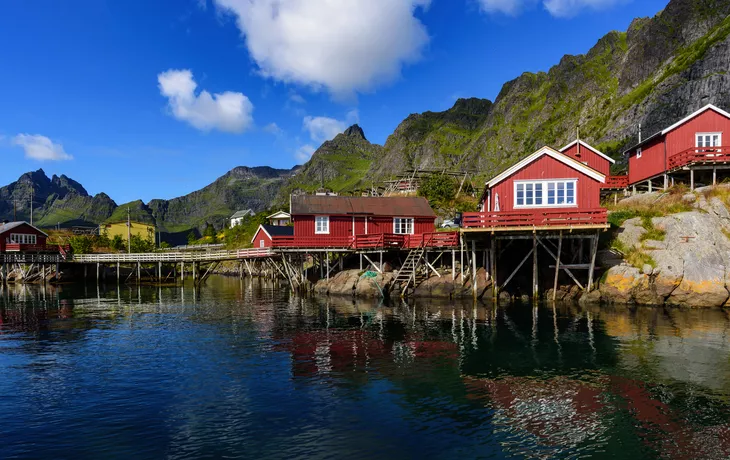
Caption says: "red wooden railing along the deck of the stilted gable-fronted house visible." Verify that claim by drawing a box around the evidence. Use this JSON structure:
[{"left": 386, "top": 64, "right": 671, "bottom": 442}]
[{"left": 463, "top": 208, "right": 608, "bottom": 229}]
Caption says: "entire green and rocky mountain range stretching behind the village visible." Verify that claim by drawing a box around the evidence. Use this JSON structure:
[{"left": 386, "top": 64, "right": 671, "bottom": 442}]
[{"left": 0, "top": 0, "right": 730, "bottom": 244}]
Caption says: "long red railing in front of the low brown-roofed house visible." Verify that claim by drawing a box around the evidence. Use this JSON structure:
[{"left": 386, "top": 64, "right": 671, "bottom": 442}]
[{"left": 272, "top": 232, "right": 459, "bottom": 250}]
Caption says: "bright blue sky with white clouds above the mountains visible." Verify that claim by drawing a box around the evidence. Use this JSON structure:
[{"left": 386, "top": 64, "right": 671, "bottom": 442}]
[{"left": 0, "top": 0, "right": 667, "bottom": 204}]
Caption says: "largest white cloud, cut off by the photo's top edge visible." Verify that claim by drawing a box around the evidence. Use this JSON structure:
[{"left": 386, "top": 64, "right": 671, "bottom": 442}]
[{"left": 215, "top": 0, "right": 430, "bottom": 97}]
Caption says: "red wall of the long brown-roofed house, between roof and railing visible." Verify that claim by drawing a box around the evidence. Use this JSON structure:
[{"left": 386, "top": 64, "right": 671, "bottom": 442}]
[{"left": 292, "top": 215, "right": 436, "bottom": 237}]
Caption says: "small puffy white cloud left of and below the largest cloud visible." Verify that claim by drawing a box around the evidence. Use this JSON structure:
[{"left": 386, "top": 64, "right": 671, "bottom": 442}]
[{"left": 157, "top": 69, "right": 253, "bottom": 133}]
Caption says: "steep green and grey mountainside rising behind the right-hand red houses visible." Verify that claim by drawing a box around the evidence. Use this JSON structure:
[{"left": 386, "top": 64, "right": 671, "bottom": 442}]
[{"left": 369, "top": 0, "right": 730, "bottom": 178}]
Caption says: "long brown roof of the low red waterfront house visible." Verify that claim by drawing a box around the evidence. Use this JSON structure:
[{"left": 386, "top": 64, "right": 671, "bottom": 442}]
[{"left": 291, "top": 195, "right": 436, "bottom": 217}]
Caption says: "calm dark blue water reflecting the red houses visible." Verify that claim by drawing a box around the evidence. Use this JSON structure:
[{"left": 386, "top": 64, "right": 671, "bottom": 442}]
[{"left": 0, "top": 279, "right": 730, "bottom": 459}]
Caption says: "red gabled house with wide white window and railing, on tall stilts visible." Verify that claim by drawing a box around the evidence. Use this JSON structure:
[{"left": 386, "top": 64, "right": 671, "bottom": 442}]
[{"left": 464, "top": 147, "right": 606, "bottom": 228}]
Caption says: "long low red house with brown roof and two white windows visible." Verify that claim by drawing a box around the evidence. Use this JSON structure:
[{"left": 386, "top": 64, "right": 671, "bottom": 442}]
[{"left": 273, "top": 195, "right": 436, "bottom": 248}]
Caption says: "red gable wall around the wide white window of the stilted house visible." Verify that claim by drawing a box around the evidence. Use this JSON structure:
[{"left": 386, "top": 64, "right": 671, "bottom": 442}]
[{"left": 492, "top": 155, "right": 601, "bottom": 212}]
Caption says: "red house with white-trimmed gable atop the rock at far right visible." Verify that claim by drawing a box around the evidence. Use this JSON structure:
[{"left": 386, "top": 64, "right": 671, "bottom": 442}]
[{"left": 624, "top": 104, "right": 730, "bottom": 191}]
